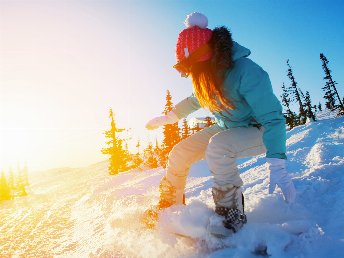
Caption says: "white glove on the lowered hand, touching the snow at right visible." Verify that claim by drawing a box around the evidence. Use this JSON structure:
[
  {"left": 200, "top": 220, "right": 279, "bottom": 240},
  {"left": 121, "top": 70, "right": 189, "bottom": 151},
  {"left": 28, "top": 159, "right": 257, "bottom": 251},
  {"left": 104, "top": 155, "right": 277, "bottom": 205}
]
[{"left": 266, "top": 158, "right": 296, "bottom": 203}]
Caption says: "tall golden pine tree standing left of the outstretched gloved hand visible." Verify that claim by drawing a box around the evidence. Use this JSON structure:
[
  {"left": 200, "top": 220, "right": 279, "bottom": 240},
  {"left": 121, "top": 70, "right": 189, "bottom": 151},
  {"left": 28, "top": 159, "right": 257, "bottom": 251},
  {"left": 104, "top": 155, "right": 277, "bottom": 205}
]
[{"left": 102, "top": 108, "right": 128, "bottom": 175}]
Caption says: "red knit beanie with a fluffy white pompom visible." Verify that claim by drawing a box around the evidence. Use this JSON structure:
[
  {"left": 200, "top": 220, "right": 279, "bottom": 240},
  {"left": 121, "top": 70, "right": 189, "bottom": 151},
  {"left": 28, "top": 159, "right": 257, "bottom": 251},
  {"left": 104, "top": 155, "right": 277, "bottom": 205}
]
[{"left": 176, "top": 12, "right": 213, "bottom": 63}]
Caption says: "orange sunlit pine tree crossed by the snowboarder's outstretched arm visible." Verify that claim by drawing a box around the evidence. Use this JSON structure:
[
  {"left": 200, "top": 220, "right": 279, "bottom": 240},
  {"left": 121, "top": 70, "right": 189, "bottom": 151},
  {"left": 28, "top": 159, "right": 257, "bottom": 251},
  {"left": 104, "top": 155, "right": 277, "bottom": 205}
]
[{"left": 160, "top": 90, "right": 180, "bottom": 167}]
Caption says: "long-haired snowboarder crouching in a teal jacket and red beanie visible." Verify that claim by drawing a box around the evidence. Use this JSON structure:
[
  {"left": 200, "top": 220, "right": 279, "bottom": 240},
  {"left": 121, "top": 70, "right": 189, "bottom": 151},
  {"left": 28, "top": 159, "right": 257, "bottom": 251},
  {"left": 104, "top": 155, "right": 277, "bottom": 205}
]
[{"left": 145, "top": 12, "right": 296, "bottom": 232}]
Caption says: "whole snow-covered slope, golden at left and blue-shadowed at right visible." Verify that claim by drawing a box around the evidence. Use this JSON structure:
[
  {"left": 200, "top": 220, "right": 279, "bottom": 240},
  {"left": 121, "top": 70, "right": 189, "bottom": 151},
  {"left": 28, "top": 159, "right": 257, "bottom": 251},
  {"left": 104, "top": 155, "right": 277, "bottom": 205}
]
[{"left": 0, "top": 117, "right": 344, "bottom": 258}]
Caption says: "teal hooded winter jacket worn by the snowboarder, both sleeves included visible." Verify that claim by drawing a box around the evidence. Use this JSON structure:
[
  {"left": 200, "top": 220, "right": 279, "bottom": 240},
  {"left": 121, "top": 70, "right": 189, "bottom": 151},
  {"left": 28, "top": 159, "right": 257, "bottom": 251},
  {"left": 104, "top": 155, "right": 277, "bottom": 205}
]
[{"left": 173, "top": 42, "right": 286, "bottom": 159}]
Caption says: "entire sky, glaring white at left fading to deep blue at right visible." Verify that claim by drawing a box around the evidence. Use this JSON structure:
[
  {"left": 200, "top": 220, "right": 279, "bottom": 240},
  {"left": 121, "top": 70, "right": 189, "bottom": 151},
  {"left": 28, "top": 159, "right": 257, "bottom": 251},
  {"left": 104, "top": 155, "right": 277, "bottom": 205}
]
[{"left": 0, "top": 0, "right": 344, "bottom": 171}]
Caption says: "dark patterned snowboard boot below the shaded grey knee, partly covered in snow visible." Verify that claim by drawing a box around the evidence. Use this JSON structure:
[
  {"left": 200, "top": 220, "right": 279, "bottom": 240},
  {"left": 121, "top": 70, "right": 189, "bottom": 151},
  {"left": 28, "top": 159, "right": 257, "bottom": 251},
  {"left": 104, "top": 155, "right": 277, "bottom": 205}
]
[{"left": 208, "top": 186, "right": 247, "bottom": 237}]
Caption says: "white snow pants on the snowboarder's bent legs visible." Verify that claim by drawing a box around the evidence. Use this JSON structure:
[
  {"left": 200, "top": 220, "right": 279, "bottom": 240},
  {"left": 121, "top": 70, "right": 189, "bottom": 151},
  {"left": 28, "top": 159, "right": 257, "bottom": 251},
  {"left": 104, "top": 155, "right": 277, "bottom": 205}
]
[{"left": 166, "top": 125, "right": 266, "bottom": 190}]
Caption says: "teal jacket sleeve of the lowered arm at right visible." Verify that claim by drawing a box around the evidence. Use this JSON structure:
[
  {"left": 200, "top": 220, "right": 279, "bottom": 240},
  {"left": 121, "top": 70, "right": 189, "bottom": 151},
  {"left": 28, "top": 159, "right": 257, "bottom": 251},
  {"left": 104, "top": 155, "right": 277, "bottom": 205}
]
[{"left": 239, "top": 59, "right": 287, "bottom": 159}]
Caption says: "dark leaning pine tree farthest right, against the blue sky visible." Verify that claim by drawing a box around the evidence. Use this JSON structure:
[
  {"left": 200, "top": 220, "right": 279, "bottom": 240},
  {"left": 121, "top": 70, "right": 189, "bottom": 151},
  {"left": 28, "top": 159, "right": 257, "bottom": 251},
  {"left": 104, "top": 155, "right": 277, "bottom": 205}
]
[{"left": 320, "top": 53, "right": 344, "bottom": 115}]
